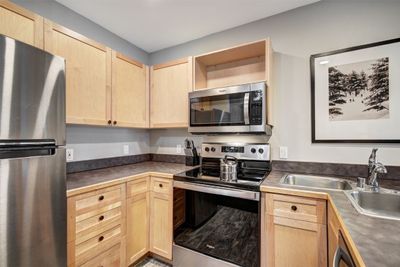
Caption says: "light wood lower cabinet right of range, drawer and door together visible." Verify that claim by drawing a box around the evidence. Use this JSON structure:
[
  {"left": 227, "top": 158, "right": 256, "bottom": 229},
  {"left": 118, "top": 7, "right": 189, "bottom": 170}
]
[{"left": 261, "top": 194, "right": 327, "bottom": 267}]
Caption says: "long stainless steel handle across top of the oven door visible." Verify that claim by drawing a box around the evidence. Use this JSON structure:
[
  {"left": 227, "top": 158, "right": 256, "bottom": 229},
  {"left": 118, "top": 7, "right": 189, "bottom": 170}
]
[{"left": 174, "top": 181, "right": 260, "bottom": 201}]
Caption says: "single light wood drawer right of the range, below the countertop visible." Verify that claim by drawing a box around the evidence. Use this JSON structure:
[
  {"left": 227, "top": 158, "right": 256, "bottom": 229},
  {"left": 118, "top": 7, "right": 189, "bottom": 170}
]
[{"left": 265, "top": 194, "right": 326, "bottom": 224}]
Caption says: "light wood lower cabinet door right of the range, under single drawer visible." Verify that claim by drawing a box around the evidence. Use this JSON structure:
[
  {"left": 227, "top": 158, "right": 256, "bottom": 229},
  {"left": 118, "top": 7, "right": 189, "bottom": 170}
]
[{"left": 266, "top": 215, "right": 326, "bottom": 267}]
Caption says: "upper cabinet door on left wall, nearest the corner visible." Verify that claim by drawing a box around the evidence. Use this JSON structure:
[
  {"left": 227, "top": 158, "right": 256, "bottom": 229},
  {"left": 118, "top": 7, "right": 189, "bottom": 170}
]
[{"left": 112, "top": 51, "right": 149, "bottom": 128}]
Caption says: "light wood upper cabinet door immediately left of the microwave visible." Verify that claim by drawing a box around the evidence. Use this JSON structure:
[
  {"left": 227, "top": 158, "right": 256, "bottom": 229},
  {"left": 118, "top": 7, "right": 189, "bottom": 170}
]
[{"left": 150, "top": 58, "right": 192, "bottom": 128}]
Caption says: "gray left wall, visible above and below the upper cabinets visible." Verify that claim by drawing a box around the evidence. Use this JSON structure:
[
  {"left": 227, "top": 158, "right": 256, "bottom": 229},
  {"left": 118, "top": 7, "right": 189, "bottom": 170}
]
[{"left": 13, "top": 0, "right": 150, "bottom": 161}]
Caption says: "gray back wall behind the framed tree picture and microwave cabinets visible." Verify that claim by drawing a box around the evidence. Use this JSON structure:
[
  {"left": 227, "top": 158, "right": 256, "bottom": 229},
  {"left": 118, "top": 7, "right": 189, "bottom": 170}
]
[{"left": 150, "top": 0, "right": 400, "bottom": 165}]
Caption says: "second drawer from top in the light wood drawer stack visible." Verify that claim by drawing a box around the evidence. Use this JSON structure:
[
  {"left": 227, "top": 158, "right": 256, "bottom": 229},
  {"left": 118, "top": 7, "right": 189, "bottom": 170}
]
[{"left": 75, "top": 207, "right": 122, "bottom": 244}]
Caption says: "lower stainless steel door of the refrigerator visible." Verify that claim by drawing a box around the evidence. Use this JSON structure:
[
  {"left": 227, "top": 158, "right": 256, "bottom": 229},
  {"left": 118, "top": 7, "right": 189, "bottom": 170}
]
[{"left": 0, "top": 148, "right": 67, "bottom": 267}]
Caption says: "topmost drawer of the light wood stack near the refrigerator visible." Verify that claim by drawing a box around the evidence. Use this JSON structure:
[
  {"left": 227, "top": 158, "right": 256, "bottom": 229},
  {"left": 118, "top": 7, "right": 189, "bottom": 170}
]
[{"left": 75, "top": 184, "right": 125, "bottom": 216}]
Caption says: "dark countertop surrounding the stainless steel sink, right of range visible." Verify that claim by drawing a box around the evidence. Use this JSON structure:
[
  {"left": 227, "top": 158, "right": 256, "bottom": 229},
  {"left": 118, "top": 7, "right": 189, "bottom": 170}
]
[{"left": 261, "top": 171, "right": 400, "bottom": 267}]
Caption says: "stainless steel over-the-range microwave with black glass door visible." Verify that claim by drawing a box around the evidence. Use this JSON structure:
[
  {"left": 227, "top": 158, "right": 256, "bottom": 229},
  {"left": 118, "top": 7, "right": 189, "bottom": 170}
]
[{"left": 189, "top": 82, "right": 271, "bottom": 135}]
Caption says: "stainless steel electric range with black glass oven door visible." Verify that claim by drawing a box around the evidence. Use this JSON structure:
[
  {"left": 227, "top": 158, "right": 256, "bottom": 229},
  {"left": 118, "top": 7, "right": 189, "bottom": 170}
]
[{"left": 173, "top": 143, "right": 271, "bottom": 267}]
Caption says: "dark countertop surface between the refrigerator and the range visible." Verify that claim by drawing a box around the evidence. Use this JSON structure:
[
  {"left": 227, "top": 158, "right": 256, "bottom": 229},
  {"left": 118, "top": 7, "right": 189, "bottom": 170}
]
[{"left": 67, "top": 161, "right": 194, "bottom": 195}]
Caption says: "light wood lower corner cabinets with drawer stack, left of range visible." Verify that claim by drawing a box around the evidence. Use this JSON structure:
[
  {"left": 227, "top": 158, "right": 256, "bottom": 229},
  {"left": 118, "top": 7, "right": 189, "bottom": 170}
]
[{"left": 67, "top": 176, "right": 173, "bottom": 267}]
